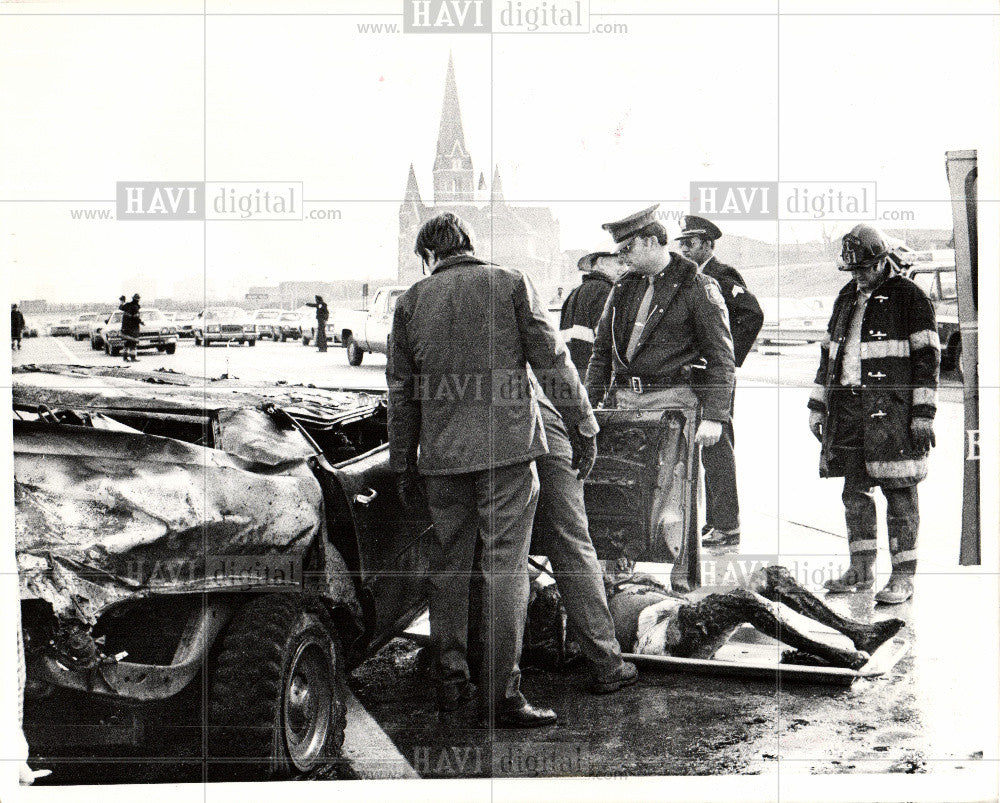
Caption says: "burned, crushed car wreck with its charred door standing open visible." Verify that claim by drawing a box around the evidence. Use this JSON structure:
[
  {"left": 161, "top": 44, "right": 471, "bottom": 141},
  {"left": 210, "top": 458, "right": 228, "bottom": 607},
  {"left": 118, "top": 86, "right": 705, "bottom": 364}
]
[{"left": 13, "top": 366, "right": 698, "bottom": 779}]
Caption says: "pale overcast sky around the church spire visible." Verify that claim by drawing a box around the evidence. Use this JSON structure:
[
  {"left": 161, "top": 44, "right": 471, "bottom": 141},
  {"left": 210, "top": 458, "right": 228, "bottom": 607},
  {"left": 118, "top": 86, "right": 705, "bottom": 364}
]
[{"left": 0, "top": 0, "right": 1000, "bottom": 301}]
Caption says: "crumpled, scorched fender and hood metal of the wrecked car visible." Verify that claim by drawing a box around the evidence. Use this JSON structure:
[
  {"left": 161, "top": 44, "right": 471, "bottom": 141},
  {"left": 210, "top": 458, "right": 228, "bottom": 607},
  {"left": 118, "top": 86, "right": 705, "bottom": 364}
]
[{"left": 13, "top": 366, "right": 377, "bottom": 624}]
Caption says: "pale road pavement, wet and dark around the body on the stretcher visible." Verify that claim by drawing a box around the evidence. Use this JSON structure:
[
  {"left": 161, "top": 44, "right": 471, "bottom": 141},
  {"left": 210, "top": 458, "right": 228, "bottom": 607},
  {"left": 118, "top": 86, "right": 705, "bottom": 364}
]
[{"left": 7, "top": 337, "right": 998, "bottom": 788}]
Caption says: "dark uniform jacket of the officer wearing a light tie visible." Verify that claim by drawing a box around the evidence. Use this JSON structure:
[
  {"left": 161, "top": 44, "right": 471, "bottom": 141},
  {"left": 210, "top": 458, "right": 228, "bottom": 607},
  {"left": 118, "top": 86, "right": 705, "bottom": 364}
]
[{"left": 587, "top": 253, "right": 735, "bottom": 422}]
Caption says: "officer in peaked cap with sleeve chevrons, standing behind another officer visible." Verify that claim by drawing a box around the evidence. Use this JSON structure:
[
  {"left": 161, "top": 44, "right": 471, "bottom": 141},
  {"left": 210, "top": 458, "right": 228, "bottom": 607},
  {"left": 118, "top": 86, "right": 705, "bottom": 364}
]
[{"left": 677, "top": 215, "right": 764, "bottom": 546}]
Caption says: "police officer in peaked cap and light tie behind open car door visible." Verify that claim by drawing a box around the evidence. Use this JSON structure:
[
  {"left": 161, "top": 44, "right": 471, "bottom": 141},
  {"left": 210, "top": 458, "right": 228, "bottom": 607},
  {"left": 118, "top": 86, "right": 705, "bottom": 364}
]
[{"left": 587, "top": 204, "right": 735, "bottom": 446}]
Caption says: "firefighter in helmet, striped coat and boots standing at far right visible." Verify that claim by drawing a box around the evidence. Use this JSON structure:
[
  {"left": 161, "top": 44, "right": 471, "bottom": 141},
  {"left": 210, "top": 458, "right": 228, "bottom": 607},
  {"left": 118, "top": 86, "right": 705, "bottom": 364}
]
[{"left": 809, "top": 223, "right": 941, "bottom": 604}]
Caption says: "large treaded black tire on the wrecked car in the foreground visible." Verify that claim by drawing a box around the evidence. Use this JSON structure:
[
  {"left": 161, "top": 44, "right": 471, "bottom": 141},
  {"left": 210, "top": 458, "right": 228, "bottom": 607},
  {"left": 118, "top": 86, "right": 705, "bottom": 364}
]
[{"left": 208, "top": 592, "right": 347, "bottom": 781}]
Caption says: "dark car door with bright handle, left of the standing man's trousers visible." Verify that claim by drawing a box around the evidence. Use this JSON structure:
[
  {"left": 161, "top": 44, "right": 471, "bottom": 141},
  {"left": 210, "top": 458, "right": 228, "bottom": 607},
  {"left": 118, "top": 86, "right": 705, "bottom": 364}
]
[{"left": 332, "top": 445, "right": 431, "bottom": 648}]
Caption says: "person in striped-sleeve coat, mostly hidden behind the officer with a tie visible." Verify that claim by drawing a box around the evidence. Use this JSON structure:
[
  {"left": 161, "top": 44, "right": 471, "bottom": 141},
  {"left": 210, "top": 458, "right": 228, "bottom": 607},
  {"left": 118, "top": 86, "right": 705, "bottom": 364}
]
[{"left": 559, "top": 251, "right": 624, "bottom": 377}]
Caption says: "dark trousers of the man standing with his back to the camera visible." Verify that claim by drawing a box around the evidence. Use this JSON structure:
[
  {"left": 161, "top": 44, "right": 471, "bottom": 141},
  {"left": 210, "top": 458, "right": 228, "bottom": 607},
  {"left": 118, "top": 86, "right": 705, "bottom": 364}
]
[{"left": 424, "top": 463, "right": 538, "bottom": 710}]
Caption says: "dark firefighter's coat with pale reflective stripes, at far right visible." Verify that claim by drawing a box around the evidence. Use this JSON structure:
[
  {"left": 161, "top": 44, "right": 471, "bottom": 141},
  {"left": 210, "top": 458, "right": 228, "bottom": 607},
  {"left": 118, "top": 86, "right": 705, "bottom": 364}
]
[{"left": 809, "top": 272, "right": 941, "bottom": 487}]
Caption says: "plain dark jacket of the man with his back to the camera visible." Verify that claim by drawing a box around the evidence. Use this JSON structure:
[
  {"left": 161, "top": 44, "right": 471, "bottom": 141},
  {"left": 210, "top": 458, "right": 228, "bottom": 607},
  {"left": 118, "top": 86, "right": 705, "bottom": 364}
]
[{"left": 386, "top": 255, "right": 597, "bottom": 474}]
